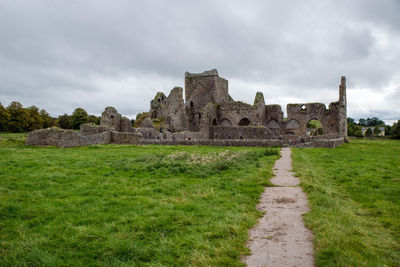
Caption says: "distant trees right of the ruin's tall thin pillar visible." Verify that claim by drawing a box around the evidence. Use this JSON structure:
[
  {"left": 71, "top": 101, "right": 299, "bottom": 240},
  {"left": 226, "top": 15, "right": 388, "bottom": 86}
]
[{"left": 347, "top": 117, "right": 400, "bottom": 139}]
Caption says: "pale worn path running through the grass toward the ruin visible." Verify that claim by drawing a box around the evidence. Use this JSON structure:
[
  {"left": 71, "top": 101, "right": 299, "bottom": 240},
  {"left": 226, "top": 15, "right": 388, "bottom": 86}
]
[{"left": 244, "top": 148, "right": 314, "bottom": 267}]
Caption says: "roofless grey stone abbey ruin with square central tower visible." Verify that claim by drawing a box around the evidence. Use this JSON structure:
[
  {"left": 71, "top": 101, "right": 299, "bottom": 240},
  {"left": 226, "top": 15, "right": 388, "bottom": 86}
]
[{"left": 27, "top": 70, "right": 347, "bottom": 147}]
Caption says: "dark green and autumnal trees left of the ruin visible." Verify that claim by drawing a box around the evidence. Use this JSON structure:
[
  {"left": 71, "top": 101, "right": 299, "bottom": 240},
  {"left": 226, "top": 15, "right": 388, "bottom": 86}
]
[{"left": 0, "top": 101, "right": 100, "bottom": 133}]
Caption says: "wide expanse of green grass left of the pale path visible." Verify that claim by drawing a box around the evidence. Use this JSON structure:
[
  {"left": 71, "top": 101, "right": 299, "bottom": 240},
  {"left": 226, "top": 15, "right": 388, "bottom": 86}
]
[{"left": 0, "top": 134, "right": 278, "bottom": 266}]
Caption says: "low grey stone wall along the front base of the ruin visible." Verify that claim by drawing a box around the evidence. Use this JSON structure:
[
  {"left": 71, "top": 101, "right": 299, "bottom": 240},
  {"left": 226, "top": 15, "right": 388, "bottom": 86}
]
[{"left": 26, "top": 126, "right": 345, "bottom": 148}]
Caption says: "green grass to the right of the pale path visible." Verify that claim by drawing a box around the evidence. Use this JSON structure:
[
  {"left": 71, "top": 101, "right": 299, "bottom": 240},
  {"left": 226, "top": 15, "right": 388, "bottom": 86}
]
[{"left": 292, "top": 140, "right": 400, "bottom": 266}]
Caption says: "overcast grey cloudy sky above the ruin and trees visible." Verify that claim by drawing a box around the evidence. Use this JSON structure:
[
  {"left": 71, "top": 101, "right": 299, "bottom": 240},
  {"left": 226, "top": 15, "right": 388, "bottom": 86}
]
[{"left": 0, "top": 0, "right": 400, "bottom": 122}]
